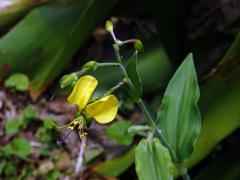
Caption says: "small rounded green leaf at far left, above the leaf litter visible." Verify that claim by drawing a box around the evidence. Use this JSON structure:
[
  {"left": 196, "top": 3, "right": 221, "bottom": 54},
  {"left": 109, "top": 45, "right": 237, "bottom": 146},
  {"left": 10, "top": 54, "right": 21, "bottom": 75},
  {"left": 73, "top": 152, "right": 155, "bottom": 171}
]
[{"left": 4, "top": 73, "right": 29, "bottom": 91}]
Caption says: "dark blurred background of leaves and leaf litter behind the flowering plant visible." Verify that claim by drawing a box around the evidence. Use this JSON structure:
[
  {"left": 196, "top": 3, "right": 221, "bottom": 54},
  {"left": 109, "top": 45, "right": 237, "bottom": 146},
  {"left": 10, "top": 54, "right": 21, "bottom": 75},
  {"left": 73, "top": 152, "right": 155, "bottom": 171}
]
[{"left": 0, "top": 0, "right": 240, "bottom": 180}]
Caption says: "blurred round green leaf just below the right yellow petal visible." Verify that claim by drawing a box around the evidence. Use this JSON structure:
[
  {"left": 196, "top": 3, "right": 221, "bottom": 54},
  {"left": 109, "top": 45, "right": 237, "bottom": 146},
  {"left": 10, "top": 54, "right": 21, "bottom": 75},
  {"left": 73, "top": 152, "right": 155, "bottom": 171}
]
[{"left": 106, "top": 120, "right": 133, "bottom": 145}]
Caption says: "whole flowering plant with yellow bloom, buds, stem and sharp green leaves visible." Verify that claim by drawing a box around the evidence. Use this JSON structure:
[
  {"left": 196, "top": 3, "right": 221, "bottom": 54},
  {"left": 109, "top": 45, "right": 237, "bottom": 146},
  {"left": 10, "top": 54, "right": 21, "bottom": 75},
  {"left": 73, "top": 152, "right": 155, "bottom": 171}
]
[{"left": 54, "top": 21, "right": 201, "bottom": 180}]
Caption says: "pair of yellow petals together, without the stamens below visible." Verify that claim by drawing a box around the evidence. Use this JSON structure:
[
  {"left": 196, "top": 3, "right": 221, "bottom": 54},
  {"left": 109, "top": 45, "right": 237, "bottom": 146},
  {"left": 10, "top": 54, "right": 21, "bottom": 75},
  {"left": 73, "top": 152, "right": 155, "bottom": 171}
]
[{"left": 68, "top": 75, "right": 118, "bottom": 124}]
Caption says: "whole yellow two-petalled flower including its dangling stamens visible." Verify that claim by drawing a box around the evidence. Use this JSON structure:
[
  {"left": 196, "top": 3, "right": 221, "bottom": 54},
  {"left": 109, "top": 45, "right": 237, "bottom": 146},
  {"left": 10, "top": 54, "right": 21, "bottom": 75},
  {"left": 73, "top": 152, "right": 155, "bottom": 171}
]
[{"left": 52, "top": 75, "right": 118, "bottom": 146}]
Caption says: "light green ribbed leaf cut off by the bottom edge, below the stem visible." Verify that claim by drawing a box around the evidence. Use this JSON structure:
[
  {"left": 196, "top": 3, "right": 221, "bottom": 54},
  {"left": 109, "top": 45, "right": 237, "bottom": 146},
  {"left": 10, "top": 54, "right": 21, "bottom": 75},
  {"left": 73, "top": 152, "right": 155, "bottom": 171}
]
[{"left": 135, "top": 138, "right": 173, "bottom": 180}]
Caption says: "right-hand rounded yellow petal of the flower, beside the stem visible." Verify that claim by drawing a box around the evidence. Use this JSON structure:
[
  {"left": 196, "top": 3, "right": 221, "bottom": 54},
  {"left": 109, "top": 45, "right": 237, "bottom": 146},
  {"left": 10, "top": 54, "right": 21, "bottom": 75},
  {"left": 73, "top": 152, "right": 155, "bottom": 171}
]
[{"left": 86, "top": 95, "right": 118, "bottom": 124}]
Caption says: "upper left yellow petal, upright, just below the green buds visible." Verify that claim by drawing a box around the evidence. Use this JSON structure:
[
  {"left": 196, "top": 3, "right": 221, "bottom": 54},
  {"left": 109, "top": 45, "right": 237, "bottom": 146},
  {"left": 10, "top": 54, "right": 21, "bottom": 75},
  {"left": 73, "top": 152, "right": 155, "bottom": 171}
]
[{"left": 68, "top": 75, "right": 98, "bottom": 111}]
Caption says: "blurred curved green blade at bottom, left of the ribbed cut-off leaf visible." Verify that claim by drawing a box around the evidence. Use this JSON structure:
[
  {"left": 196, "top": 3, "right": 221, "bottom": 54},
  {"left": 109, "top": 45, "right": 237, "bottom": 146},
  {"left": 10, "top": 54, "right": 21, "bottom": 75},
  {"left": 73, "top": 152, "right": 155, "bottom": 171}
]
[{"left": 93, "top": 147, "right": 135, "bottom": 176}]
